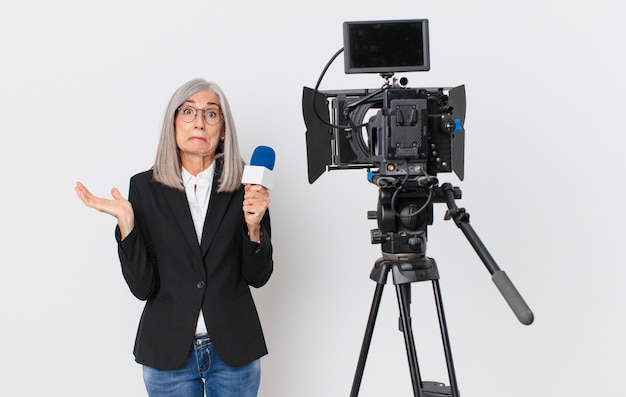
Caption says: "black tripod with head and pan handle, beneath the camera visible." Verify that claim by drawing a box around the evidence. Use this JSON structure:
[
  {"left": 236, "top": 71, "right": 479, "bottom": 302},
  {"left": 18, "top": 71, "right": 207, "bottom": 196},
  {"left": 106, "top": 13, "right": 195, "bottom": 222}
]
[{"left": 350, "top": 183, "right": 533, "bottom": 397}]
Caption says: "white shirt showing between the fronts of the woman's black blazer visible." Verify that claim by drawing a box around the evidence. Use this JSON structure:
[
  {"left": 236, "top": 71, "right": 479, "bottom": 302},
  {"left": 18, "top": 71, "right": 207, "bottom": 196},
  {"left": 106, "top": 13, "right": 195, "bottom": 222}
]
[{"left": 181, "top": 162, "right": 215, "bottom": 335}]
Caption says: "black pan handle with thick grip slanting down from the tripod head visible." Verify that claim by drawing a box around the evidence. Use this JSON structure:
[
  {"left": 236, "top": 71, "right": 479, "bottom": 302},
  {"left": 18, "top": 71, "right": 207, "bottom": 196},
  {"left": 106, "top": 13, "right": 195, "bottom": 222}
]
[{"left": 441, "top": 183, "right": 534, "bottom": 325}]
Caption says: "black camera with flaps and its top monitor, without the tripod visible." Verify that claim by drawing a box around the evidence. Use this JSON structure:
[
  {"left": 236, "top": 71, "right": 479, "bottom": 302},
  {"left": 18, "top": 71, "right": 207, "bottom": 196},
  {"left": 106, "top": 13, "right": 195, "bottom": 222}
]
[{"left": 302, "top": 19, "right": 465, "bottom": 183}]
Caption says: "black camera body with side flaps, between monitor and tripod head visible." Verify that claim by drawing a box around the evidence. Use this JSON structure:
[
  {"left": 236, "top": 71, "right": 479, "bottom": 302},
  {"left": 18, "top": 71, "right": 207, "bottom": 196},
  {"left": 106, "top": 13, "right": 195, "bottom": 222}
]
[{"left": 303, "top": 85, "right": 465, "bottom": 183}]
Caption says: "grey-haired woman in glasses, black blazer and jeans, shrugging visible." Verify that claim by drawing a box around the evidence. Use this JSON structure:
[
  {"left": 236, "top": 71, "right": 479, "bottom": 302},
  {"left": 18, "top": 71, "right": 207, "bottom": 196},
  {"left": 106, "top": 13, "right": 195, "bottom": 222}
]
[{"left": 76, "top": 79, "right": 273, "bottom": 397}]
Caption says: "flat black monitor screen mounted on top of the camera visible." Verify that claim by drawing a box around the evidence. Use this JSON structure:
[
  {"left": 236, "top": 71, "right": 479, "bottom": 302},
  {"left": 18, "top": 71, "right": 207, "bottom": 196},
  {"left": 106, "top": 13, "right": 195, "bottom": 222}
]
[{"left": 343, "top": 19, "right": 430, "bottom": 74}]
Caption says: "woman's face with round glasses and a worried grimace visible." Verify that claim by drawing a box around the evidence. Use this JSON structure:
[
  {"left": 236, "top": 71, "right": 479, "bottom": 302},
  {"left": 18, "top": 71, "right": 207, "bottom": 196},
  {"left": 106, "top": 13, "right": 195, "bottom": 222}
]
[{"left": 174, "top": 90, "right": 225, "bottom": 166}]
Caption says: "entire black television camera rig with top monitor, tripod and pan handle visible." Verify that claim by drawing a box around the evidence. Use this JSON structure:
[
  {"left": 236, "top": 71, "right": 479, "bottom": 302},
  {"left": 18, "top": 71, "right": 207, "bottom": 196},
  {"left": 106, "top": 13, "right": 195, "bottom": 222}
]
[{"left": 302, "top": 19, "right": 533, "bottom": 397}]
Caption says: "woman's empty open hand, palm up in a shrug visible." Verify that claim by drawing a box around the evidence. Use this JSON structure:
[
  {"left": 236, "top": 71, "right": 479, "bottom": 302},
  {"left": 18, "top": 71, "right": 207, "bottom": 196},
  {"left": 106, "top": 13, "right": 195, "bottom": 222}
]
[{"left": 74, "top": 182, "right": 135, "bottom": 240}]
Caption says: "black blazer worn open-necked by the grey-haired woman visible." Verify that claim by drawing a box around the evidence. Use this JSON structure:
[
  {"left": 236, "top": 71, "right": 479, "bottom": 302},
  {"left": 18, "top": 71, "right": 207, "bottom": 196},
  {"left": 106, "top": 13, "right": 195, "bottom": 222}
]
[{"left": 116, "top": 163, "right": 273, "bottom": 369}]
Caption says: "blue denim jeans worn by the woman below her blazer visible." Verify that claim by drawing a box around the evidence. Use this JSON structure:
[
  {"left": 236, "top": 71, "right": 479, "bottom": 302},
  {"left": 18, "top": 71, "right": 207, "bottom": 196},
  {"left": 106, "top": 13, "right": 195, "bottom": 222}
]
[{"left": 143, "top": 335, "right": 261, "bottom": 397}]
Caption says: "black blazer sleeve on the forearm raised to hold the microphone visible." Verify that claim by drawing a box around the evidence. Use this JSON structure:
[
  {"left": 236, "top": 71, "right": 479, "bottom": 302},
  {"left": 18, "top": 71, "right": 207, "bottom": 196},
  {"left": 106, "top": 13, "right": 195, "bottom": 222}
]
[{"left": 242, "top": 210, "right": 274, "bottom": 288}]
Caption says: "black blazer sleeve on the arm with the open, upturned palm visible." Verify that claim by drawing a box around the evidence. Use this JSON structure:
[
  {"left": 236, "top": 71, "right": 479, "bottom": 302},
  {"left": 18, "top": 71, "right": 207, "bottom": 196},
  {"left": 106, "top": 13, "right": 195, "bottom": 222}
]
[{"left": 115, "top": 178, "right": 159, "bottom": 300}]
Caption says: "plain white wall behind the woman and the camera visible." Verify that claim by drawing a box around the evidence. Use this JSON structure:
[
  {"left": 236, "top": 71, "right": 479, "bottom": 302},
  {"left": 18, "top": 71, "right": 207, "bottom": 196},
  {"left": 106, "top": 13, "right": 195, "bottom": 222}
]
[{"left": 0, "top": 0, "right": 626, "bottom": 397}]
